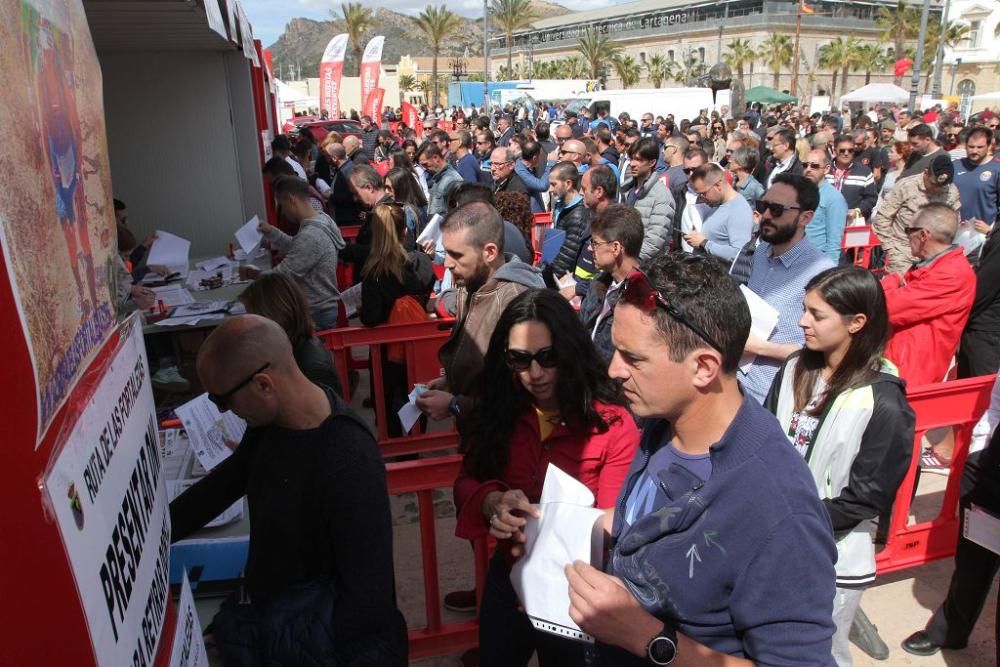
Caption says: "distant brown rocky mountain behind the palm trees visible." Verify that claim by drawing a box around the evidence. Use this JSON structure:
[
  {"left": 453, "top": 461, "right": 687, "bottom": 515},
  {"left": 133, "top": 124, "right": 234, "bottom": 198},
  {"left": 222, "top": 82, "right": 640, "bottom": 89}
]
[{"left": 267, "top": 0, "right": 572, "bottom": 79}]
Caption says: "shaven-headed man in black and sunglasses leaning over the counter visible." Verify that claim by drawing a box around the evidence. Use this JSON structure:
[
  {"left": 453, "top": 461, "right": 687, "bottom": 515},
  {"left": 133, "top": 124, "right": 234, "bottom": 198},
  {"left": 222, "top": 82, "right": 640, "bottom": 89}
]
[{"left": 170, "top": 315, "right": 407, "bottom": 667}]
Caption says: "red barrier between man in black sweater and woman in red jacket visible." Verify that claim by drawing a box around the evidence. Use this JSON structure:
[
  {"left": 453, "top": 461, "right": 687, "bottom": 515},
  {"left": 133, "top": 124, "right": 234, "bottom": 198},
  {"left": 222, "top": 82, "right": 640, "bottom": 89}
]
[{"left": 386, "top": 455, "right": 490, "bottom": 660}]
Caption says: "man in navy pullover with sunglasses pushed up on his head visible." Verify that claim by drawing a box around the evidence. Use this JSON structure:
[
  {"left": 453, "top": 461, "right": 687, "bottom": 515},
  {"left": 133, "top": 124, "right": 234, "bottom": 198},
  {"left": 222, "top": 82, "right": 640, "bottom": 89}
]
[{"left": 566, "top": 252, "right": 836, "bottom": 667}]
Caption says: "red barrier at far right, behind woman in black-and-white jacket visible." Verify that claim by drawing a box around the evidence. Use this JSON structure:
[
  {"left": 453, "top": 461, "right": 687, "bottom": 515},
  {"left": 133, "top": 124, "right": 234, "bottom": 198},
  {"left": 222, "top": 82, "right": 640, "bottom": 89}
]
[{"left": 875, "top": 375, "right": 996, "bottom": 574}]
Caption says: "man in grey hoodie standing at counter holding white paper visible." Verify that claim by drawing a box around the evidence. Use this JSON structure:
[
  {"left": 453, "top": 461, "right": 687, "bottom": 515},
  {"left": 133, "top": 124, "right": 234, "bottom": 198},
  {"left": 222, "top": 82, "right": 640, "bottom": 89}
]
[{"left": 240, "top": 176, "right": 345, "bottom": 330}]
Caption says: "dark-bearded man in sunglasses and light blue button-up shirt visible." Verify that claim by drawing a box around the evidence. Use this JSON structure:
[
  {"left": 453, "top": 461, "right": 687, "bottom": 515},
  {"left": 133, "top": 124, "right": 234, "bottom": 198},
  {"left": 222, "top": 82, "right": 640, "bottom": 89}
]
[{"left": 740, "top": 173, "right": 835, "bottom": 401}]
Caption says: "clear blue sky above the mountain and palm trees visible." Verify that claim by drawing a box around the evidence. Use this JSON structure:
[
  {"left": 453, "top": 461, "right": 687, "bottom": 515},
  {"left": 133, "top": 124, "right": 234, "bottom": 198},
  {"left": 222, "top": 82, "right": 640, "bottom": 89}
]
[{"left": 242, "top": 0, "right": 623, "bottom": 46}]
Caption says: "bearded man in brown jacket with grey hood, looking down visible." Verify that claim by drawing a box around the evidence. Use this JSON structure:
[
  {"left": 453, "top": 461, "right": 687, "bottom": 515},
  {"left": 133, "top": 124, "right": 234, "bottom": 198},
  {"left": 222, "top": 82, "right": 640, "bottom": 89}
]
[{"left": 417, "top": 202, "right": 545, "bottom": 433}]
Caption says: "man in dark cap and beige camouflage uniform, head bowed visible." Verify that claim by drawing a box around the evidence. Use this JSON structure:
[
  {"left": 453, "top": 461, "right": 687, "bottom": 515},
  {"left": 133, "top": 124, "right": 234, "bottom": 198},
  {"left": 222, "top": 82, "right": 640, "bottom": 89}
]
[{"left": 872, "top": 153, "right": 961, "bottom": 273}]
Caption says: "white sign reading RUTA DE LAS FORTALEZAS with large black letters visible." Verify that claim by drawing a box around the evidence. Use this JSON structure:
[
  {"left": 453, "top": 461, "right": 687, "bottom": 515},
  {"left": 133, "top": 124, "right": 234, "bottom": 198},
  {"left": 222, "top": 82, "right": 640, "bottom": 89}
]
[{"left": 44, "top": 315, "right": 170, "bottom": 667}]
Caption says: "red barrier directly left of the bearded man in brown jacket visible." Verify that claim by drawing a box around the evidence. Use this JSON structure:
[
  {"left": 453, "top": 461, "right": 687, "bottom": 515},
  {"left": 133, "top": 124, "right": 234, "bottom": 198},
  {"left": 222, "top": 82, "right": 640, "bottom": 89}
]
[{"left": 317, "top": 319, "right": 458, "bottom": 456}]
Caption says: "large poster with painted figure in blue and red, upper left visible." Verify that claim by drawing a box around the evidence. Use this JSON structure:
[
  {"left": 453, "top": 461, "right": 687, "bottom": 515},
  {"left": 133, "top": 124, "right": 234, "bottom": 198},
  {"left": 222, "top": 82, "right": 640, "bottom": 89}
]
[{"left": 0, "top": 0, "right": 117, "bottom": 448}]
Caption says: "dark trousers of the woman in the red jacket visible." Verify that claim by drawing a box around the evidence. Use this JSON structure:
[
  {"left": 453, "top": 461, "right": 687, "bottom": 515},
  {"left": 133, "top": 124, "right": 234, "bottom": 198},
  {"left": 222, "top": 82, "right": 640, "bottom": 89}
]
[{"left": 479, "top": 551, "right": 586, "bottom": 667}]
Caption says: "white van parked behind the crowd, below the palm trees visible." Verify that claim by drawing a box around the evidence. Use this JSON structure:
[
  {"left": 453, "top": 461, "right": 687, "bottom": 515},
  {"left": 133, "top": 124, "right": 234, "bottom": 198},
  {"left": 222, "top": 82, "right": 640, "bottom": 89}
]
[{"left": 566, "top": 88, "right": 729, "bottom": 124}]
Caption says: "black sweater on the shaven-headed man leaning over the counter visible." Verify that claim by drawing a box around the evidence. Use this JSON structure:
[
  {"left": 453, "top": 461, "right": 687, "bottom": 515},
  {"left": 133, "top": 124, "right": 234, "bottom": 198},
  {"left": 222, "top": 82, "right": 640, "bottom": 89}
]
[{"left": 170, "top": 391, "right": 407, "bottom": 665}]
